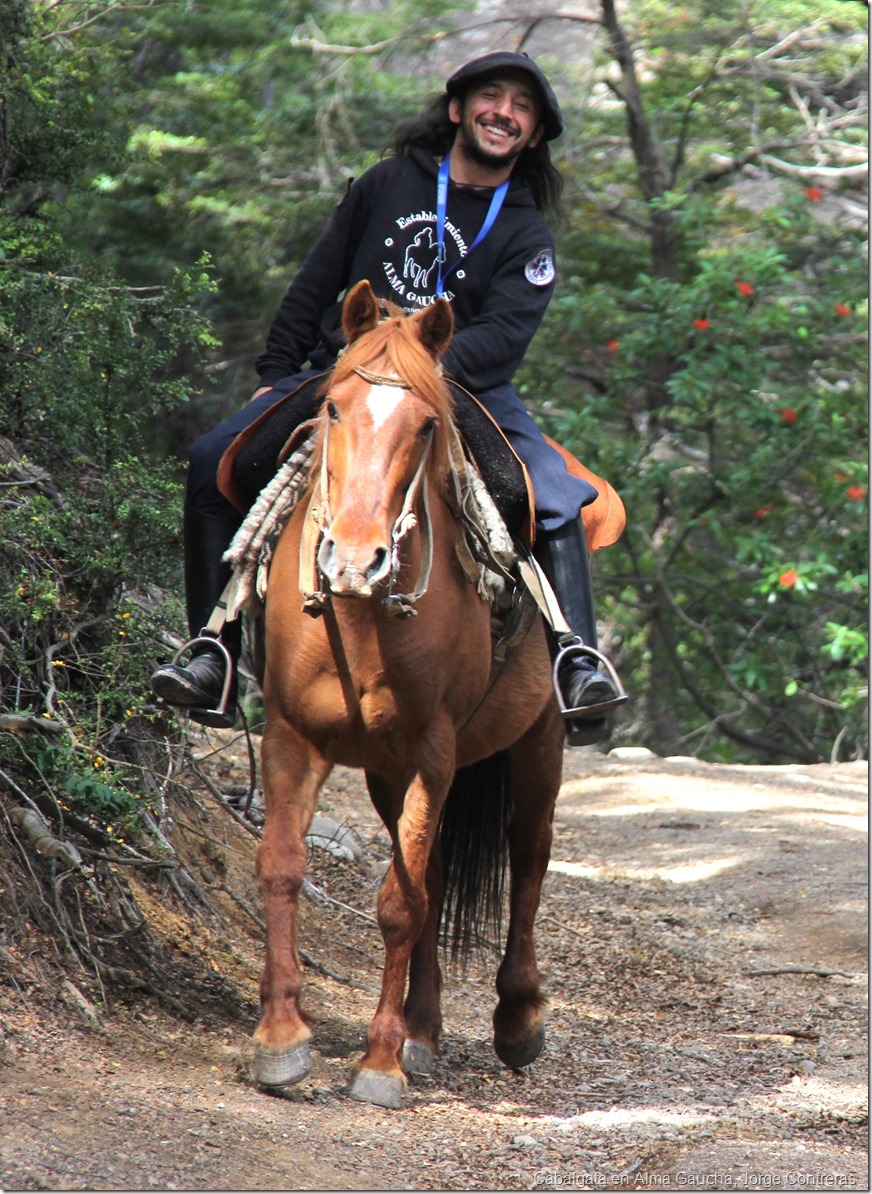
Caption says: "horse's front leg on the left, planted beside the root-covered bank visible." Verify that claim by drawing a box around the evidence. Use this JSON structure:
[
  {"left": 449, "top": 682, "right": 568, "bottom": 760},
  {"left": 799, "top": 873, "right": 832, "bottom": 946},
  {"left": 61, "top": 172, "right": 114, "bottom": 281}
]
[{"left": 254, "top": 720, "right": 331, "bottom": 1088}]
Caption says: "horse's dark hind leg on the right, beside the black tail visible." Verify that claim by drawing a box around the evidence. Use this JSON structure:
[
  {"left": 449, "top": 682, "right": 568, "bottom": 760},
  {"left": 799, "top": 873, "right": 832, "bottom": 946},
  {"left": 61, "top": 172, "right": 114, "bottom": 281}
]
[{"left": 493, "top": 707, "right": 564, "bottom": 1070}]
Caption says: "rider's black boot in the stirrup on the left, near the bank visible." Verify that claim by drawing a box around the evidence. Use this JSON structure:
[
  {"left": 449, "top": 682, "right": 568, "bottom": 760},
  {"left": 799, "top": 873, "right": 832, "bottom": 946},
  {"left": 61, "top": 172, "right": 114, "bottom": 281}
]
[{"left": 152, "top": 505, "right": 242, "bottom": 728}]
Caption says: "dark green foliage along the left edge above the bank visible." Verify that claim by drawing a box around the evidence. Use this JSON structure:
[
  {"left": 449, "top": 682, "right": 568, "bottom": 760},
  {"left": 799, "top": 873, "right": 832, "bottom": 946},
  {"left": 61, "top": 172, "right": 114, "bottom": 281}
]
[{"left": 0, "top": 4, "right": 216, "bottom": 831}]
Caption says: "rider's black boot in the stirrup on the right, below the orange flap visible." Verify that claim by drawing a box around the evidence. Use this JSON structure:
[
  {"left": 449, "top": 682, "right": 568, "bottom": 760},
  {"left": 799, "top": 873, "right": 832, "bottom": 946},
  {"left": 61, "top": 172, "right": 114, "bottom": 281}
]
[{"left": 533, "top": 519, "right": 627, "bottom": 746}]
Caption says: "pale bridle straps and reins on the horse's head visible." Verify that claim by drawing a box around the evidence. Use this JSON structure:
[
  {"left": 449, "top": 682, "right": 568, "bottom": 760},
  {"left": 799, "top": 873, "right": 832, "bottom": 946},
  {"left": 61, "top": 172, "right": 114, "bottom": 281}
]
[{"left": 299, "top": 365, "right": 432, "bottom": 617}]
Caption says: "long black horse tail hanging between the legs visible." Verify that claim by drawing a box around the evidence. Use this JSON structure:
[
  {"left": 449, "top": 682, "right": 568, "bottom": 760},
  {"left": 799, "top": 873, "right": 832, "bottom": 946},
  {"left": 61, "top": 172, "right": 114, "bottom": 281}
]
[{"left": 438, "top": 751, "right": 511, "bottom": 964}]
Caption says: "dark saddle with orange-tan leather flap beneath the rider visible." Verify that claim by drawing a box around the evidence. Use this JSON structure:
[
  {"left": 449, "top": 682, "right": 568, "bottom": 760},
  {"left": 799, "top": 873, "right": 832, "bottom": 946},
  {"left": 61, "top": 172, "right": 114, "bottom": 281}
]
[{"left": 217, "top": 373, "right": 626, "bottom": 552}]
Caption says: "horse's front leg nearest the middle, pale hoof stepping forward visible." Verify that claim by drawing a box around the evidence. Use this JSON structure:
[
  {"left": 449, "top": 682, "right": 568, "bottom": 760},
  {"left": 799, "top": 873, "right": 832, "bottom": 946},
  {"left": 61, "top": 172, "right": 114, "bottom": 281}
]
[{"left": 350, "top": 743, "right": 454, "bottom": 1107}]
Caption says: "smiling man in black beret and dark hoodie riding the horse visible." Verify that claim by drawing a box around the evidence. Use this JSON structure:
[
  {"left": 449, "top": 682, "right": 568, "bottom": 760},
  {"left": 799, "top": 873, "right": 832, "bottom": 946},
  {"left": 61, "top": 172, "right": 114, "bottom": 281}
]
[{"left": 152, "top": 51, "right": 625, "bottom": 740}]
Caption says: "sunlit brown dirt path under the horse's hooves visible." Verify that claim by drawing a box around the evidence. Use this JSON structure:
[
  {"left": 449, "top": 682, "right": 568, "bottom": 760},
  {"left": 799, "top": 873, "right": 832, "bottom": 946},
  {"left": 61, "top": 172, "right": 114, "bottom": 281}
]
[{"left": 0, "top": 752, "right": 868, "bottom": 1190}]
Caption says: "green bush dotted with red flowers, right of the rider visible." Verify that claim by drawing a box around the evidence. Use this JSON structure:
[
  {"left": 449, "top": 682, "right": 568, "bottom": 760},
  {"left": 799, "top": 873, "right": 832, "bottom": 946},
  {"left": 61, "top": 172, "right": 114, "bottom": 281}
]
[{"left": 532, "top": 186, "right": 868, "bottom": 762}]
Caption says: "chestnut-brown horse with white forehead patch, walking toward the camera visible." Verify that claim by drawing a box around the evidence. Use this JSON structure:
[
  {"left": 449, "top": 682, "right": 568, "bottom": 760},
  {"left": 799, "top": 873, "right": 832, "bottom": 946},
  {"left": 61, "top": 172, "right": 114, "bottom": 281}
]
[{"left": 254, "top": 283, "right": 564, "bottom": 1107}]
